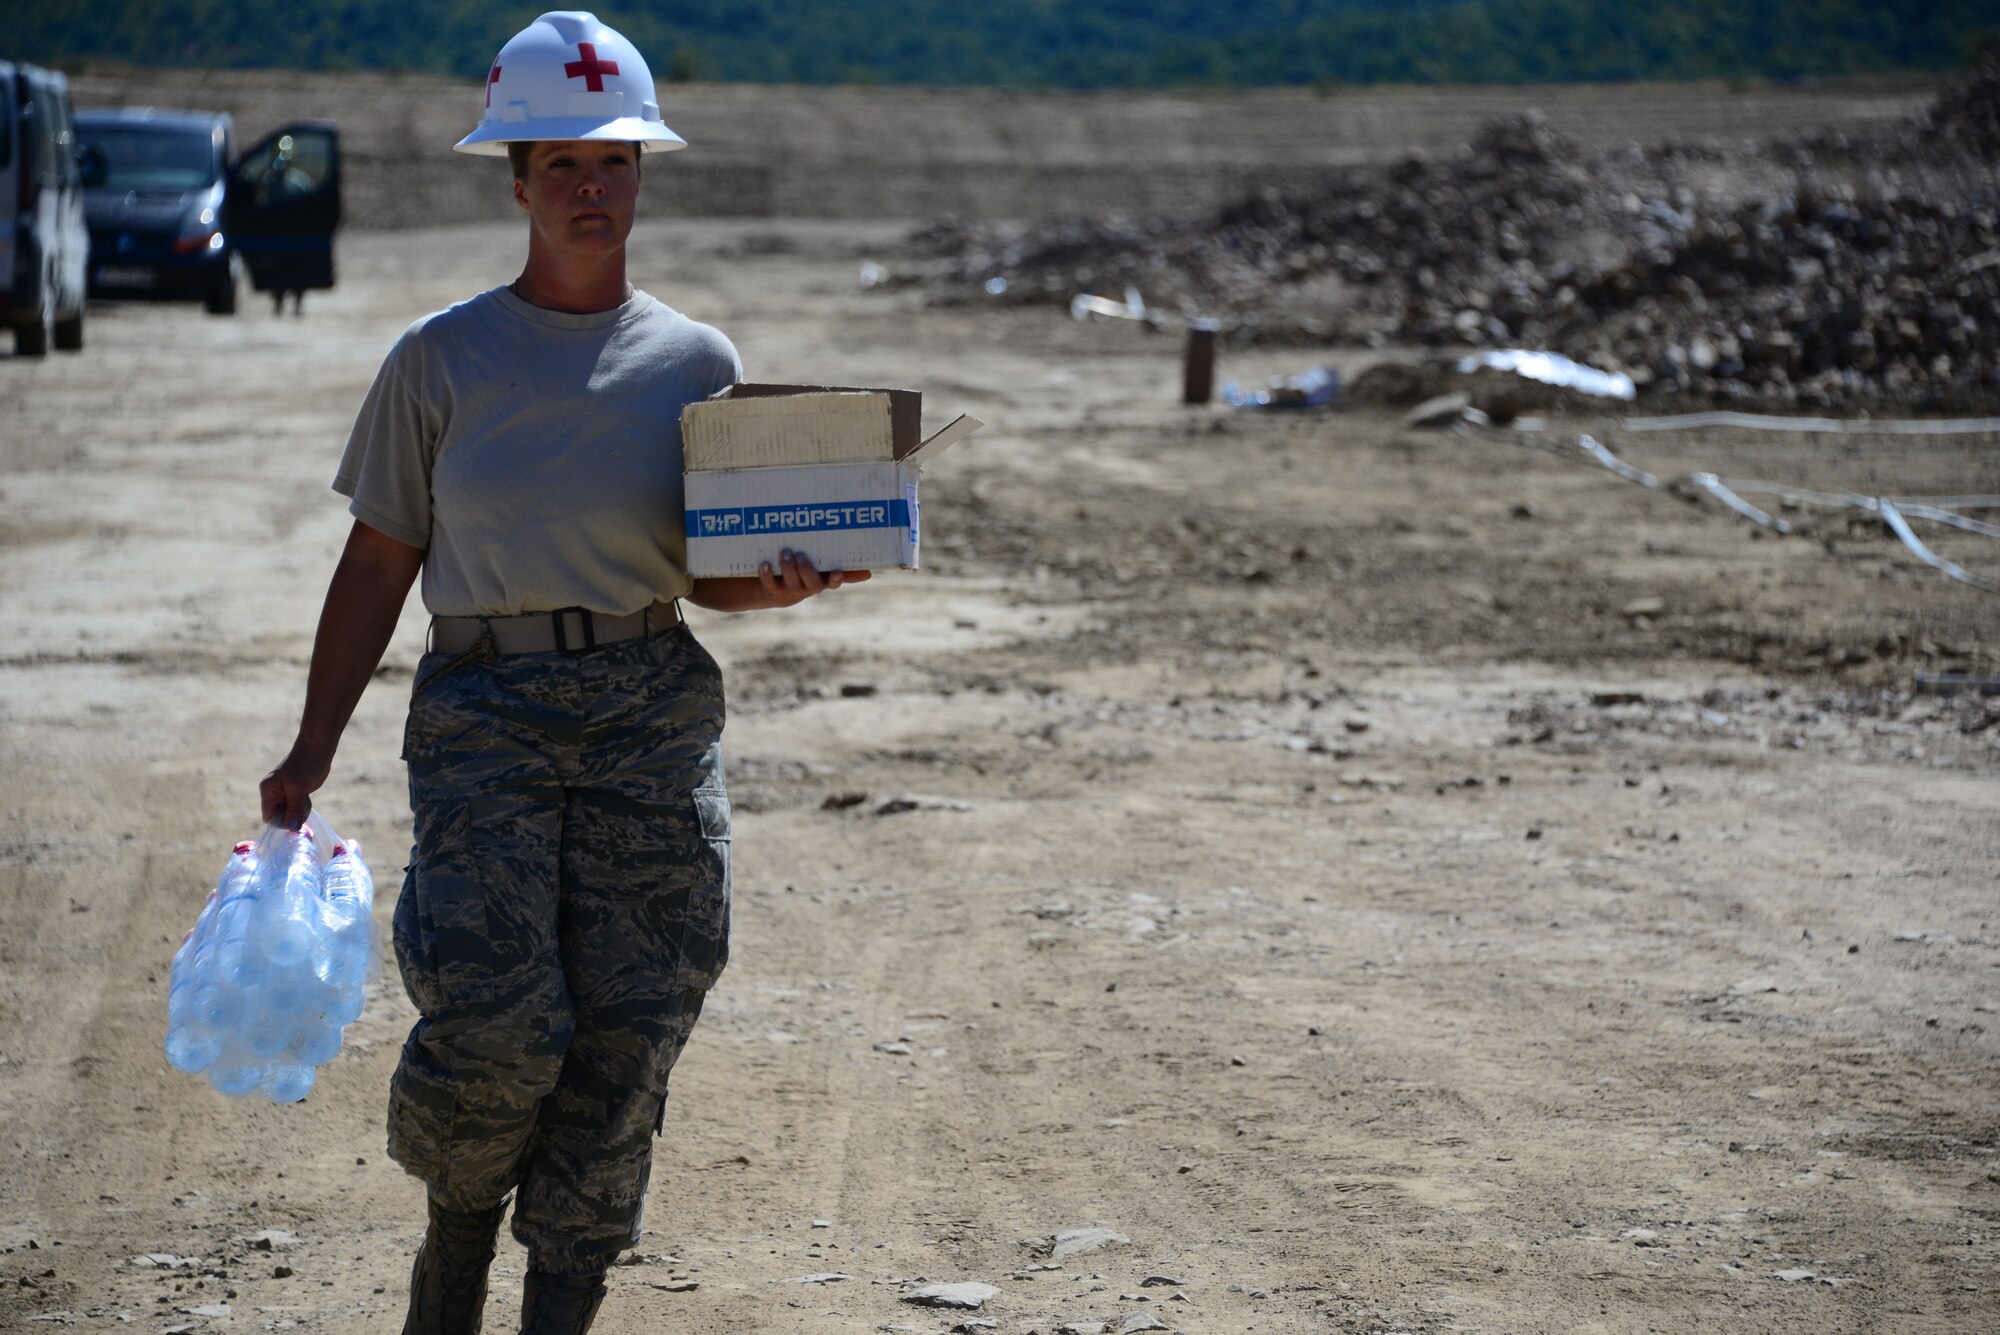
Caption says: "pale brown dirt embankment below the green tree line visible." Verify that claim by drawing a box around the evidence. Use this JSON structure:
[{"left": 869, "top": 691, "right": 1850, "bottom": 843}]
[{"left": 74, "top": 70, "right": 1934, "bottom": 228}]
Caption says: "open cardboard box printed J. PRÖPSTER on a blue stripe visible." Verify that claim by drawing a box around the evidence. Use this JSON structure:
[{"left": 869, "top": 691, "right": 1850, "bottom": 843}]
[{"left": 680, "top": 384, "right": 984, "bottom": 580}]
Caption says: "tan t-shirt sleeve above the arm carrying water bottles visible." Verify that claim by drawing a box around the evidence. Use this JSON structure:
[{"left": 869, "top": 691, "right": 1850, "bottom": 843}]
[{"left": 334, "top": 324, "right": 444, "bottom": 550}]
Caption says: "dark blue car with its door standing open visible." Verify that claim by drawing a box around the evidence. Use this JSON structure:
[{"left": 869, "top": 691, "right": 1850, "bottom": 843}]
[{"left": 76, "top": 108, "right": 340, "bottom": 316}]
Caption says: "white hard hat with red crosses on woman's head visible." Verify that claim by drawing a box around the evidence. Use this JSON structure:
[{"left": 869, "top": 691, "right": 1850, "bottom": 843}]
[{"left": 452, "top": 10, "right": 688, "bottom": 156}]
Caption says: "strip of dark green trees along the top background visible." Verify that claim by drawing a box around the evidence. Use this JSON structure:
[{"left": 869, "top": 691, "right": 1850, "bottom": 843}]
[{"left": 15, "top": 0, "right": 2000, "bottom": 88}]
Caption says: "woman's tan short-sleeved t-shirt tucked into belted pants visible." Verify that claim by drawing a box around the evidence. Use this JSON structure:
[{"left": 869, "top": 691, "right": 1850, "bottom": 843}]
[{"left": 334, "top": 288, "right": 742, "bottom": 616}]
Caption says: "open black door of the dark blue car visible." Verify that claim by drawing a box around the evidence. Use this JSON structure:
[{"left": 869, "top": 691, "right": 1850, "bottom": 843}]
[{"left": 222, "top": 120, "right": 340, "bottom": 292}]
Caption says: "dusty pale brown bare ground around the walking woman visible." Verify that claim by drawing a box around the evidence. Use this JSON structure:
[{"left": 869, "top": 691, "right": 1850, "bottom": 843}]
[{"left": 0, "top": 208, "right": 2000, "bottom": 1335}]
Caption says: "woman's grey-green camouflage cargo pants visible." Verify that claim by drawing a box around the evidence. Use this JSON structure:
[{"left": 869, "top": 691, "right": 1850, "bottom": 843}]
[{"left": 388, "top": 626, "right": 730, "bottom": 1273}]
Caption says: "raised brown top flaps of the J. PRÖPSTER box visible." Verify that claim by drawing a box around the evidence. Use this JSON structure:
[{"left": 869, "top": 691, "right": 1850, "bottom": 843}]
[{"left": 680, "top": 382, "right": 984, "bottom": 472}]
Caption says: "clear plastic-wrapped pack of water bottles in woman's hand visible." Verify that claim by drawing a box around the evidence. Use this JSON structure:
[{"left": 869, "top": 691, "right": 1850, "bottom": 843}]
[{"left": 166, "top": 813, "right": 376, "bottom": 1103}]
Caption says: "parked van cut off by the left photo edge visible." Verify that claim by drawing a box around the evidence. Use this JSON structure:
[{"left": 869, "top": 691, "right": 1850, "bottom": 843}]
[{"left": 0, "top": 60, "right": 90, "bottom": 358}]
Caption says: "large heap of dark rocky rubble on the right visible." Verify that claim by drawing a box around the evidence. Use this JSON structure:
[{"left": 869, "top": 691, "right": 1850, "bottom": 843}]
[{"left": 912, "top": 56, "right": 2000, "bottom": 408}]
